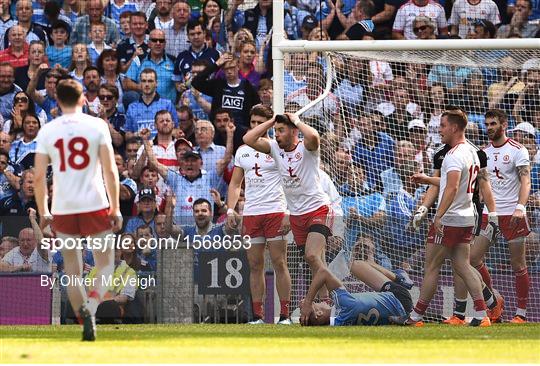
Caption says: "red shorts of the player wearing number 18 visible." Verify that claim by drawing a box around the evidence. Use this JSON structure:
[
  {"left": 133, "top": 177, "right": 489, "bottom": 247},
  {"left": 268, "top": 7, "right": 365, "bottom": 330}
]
[{"left": 52, "top": 208, "right": 112, "bottom": 236}]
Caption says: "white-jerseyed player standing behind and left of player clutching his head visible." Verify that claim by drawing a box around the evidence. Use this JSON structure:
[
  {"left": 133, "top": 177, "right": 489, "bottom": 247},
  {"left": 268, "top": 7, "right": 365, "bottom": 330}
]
[{"left": 227, "top": 104, "right": 292, "bottom": 325}]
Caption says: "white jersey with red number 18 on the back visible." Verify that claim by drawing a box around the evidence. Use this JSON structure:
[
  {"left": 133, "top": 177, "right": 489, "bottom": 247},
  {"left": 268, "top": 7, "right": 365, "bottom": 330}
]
[{"left": 36, "top": 113, "right": 112, "bottom": 215}]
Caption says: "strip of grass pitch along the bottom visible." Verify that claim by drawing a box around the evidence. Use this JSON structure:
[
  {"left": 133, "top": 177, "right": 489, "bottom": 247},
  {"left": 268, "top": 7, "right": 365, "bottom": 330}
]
[{"left": 0, "top": 324, "right": 540, "bottom": 363}]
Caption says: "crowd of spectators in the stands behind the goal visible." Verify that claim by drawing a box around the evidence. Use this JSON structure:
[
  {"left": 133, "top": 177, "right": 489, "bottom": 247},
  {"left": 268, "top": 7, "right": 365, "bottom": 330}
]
[{"left": 0, "top": 0, "right": 540, "bottom": 320}]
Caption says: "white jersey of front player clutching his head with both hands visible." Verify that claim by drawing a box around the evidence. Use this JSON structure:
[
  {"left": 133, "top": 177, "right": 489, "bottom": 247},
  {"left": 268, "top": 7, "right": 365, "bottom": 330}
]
[{"left": 270, "top": 140, "right": 330, "bottom": 215}]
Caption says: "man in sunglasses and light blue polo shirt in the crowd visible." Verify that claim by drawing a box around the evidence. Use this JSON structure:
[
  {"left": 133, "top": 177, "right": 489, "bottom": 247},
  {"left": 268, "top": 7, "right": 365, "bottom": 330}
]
[{"left": 125, "top": 29, "right": 176, "bottom": 103}]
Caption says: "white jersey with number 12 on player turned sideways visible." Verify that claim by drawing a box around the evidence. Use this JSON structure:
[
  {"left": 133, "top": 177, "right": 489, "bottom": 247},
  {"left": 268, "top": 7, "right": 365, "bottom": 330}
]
[{"left": 439, "top": 142, "right": 480, "bottom": 227}]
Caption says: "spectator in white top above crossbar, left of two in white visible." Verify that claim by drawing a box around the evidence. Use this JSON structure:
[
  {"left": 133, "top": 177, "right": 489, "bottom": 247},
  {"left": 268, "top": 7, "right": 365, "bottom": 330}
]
[{"left": 392, "top": 0, "right": 448, "bottom": 39}]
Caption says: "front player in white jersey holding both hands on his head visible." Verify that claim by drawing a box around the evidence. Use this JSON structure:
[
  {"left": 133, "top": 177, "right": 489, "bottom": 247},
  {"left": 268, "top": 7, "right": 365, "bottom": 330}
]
[{"left": 244, "top": 113, "right": 332, "bottom": 300}]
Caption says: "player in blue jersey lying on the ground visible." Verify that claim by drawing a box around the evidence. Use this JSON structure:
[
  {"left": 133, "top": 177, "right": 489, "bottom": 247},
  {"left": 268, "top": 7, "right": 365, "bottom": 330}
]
[{"left": 300, "top": 260, "right": 412, "bottom": 326}]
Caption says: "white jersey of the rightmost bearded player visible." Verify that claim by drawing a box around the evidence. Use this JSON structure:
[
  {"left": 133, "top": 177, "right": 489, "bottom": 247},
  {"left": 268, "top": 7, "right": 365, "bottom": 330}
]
[{"left": 484, "top": 138, "right": 530, "bottom": 215}]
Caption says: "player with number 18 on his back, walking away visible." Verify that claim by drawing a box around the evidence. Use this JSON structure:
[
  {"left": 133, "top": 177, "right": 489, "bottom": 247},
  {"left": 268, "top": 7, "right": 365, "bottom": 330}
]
[{"left": 34, "top": 80, "right": 122, "bottom": 341}]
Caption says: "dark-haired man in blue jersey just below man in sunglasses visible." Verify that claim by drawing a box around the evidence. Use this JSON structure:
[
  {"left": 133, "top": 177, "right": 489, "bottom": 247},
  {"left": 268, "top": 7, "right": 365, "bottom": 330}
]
[{"left": 125, "top": 67, "right": 178, "bottom": 139}]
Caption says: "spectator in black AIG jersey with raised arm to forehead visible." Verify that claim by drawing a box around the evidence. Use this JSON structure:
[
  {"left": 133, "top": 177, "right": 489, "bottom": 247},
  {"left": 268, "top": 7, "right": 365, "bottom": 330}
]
[{"left": 192, "top": 53, "right": 260, "bottom": 128}]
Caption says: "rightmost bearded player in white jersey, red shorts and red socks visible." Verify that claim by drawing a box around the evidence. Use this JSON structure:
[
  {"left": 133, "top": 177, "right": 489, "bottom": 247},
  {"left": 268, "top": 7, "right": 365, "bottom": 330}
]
[{"left": 456, "top": 109, "right": 531, "bottom": 324}]
